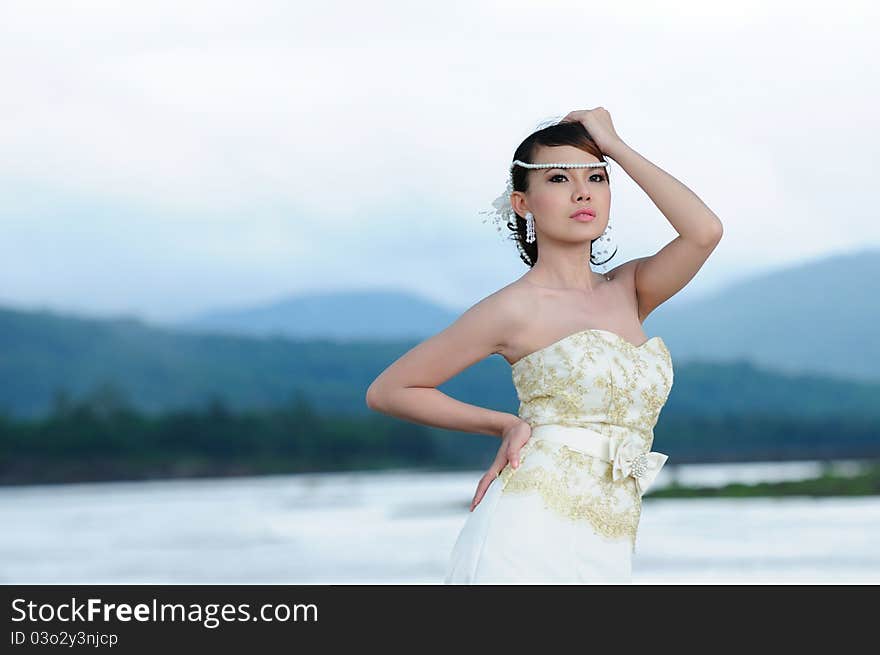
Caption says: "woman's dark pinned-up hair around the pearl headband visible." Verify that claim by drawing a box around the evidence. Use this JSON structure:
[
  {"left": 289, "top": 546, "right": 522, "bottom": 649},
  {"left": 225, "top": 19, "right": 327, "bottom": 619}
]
[{"left": 507, "top": 121, "right": 617, "bottom": 267}]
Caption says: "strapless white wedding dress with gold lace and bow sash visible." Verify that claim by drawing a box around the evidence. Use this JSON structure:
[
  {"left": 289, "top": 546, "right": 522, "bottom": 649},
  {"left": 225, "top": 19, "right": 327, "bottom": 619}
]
[{"left": 444, "top": 328, "right": 673, "bottom": 584}]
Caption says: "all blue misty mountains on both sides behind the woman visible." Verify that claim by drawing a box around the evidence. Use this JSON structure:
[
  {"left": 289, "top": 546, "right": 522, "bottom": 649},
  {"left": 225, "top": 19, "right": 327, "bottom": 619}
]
[{"left": 0, "top": 252, "right": 880, "bottom": 416}]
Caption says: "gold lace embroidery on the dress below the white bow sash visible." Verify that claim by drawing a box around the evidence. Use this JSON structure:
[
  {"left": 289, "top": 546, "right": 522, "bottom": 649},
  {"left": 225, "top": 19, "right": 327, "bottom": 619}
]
[{"left": 498, "top": 438, "right": 641, "bottom": 551}]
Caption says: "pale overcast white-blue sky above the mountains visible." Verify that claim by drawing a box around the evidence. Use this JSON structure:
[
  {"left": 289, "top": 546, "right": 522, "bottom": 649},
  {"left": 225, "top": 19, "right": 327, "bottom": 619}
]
[{"left": 0, "top": 0, "right": 880, "bottom": 322}]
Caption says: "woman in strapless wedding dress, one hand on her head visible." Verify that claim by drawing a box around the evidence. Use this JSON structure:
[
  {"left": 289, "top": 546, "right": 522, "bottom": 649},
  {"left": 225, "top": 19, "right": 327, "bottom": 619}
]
[{"left": 367, "top": 107, "right": 722, "bottom": 584}]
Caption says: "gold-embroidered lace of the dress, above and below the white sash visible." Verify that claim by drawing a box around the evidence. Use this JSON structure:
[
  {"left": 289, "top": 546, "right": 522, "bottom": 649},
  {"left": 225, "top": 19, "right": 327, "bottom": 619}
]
[{"left": 499, "top": 328, "right": 673, "bottom": 550}]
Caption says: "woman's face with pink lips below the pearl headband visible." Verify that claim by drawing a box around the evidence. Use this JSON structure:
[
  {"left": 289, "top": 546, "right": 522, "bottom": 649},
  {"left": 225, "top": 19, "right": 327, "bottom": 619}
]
[{"left": 510, "top": 146, "right": 611, "bottom": 242}]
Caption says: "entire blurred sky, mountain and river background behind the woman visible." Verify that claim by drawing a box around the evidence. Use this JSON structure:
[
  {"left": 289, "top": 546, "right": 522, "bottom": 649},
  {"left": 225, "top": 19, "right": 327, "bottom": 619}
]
[{"left": 0, "top": 0, "right": 880, "bottom": 584}]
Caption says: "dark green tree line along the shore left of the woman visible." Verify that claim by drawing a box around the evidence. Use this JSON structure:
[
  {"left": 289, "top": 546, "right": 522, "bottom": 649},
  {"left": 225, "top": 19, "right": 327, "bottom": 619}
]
[{"left": 0, "top": 384, "right": 437, "bottom": 483}]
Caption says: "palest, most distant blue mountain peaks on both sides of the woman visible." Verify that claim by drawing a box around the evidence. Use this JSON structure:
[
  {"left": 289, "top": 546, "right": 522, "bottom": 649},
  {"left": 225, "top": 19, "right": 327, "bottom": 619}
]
[{"left": 172, "top": 250, "right": 880, "bottom": 380}]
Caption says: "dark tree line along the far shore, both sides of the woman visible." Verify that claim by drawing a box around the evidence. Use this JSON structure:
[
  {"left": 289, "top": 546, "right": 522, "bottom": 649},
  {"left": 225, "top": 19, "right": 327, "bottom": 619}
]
[{"left": 0, "top": 383, "right": 880, "bottom": 484}]
